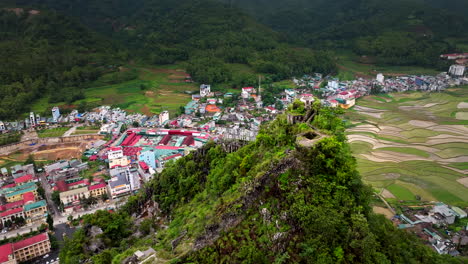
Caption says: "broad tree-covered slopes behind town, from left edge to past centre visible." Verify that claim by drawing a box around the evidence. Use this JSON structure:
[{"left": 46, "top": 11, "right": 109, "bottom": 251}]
[{"left": 0, "top": 0, "right": 336, "bottom": 119}]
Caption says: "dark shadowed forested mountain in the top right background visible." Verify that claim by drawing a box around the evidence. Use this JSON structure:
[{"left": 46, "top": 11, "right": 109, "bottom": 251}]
[{"left": 223, "top": 0, "right": 468, "bottom": 66}]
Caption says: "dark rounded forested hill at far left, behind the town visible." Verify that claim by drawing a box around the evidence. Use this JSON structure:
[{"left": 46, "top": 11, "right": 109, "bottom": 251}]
[{"left": 0, "top": 8, "right": 122, "bottom": 119}]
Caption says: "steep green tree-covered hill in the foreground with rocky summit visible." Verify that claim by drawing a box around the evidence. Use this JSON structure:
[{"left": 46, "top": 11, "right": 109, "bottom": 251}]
[{"left": 56, "top": 103, "right": 462, "bottom": 263}]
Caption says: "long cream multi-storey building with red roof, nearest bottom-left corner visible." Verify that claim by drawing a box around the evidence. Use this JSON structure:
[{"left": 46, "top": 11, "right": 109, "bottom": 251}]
[{"left": 11, "top": 233, "right": 50, "bottom": 262}]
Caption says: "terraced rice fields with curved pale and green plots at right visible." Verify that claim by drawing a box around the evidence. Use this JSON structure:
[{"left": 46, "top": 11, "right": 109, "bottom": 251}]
[{"left": 346, "top": 86, "right": 468, "bottom": 206}]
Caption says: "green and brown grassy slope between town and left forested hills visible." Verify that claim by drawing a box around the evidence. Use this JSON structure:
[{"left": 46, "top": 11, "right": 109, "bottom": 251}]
[{"left": 32, "top": 64, "right": 199, "bottom": 115}]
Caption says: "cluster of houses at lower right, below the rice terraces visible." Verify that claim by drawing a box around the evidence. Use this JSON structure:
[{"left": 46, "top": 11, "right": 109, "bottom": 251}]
[{"left": 393, "top": 203, "right": 468, "bottom": 256}]
